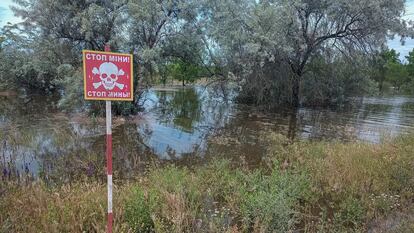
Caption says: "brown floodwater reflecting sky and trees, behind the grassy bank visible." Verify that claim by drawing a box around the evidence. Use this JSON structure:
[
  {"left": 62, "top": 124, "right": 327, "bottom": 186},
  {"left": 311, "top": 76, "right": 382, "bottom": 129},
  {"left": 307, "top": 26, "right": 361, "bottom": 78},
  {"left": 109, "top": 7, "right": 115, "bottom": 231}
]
[{"left": 0, "top": 87, "right": 414, "bottom": 182}]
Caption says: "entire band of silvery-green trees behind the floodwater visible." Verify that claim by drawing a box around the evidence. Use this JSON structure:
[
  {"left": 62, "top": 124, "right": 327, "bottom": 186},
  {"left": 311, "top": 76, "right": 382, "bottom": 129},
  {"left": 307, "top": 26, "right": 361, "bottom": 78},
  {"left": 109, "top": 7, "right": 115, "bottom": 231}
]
[{"left": 0, "top": 0, "right": 414, "bottom": 115}]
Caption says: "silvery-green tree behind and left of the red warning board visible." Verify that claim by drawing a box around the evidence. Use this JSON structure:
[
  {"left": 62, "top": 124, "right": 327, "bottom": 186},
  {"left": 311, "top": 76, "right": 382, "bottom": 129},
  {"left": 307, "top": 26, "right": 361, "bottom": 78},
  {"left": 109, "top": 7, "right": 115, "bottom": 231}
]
[{"left": 7, "top": 0, "right": 126, "bottom": 91}]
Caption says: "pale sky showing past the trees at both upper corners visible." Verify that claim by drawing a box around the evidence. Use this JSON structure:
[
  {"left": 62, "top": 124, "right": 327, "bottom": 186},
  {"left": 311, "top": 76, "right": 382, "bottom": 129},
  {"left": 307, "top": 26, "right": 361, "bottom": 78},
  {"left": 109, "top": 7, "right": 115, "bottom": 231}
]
[{"left": 0, "top": 0, "right": 414, "bottom": 61}]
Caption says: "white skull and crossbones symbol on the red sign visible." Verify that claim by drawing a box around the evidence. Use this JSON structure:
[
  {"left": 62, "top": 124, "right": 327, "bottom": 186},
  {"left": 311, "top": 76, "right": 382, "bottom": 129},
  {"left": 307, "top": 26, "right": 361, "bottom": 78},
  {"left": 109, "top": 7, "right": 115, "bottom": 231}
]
[{"left": 92, "top": 62, "right": 125, "bottom": 90}]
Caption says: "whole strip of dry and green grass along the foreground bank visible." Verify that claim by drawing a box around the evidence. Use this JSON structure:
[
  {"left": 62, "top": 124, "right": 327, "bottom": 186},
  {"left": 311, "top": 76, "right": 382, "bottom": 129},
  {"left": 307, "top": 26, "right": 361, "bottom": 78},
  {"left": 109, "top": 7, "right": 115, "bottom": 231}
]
[{"left": 0, "top": 134, "right": 414, "bottom": 232}]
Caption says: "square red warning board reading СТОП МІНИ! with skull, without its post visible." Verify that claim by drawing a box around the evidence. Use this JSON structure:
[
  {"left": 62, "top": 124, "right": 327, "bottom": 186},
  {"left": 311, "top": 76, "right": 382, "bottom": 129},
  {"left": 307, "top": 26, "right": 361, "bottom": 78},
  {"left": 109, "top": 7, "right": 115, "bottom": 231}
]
[{"left": 82, "top": 50, "right": 134, "bottom": 101}]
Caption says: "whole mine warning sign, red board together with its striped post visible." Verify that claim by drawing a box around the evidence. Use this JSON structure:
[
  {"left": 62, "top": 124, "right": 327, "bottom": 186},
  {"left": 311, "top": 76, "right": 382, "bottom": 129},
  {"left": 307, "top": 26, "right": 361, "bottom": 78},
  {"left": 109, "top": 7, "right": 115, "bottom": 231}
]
[{"left": 82, "top": 44, "right": 134, "bottom": 233}]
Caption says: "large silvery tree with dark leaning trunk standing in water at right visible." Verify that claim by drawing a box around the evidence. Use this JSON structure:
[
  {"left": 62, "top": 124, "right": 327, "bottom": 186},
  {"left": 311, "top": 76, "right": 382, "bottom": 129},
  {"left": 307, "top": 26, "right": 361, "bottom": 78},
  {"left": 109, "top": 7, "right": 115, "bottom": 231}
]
[{"left": 206, "top": 0, "right": 406, "bottom": 107}]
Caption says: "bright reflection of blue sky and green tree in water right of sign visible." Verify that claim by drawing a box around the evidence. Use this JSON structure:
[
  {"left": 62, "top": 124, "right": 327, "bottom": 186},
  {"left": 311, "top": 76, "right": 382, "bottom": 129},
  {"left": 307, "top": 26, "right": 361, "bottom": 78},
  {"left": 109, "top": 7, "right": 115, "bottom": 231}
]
[{"left": 136, "top": 88, "right": 232, "bottom": 160}]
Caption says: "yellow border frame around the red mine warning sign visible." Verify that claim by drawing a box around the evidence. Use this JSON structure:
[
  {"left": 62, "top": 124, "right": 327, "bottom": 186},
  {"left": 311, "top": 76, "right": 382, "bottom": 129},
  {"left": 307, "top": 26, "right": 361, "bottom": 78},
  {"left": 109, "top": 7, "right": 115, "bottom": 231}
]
[{"left": 82, "top": 49, "right": 134, "bottom": 101}]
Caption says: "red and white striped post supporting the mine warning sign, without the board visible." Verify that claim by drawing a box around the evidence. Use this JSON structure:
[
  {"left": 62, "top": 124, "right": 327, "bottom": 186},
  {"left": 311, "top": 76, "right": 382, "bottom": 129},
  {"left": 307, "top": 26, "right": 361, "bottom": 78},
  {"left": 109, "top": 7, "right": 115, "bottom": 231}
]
[{"left": 105, "top": 44, "right": 113, "bottom": 233}]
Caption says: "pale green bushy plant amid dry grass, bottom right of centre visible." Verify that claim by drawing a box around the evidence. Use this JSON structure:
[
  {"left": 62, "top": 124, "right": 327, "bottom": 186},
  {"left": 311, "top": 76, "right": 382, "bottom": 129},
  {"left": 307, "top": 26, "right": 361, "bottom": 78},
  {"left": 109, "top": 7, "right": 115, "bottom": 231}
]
[{"left": 241, "top": 169, "right": 309, "bottom": 232}]
